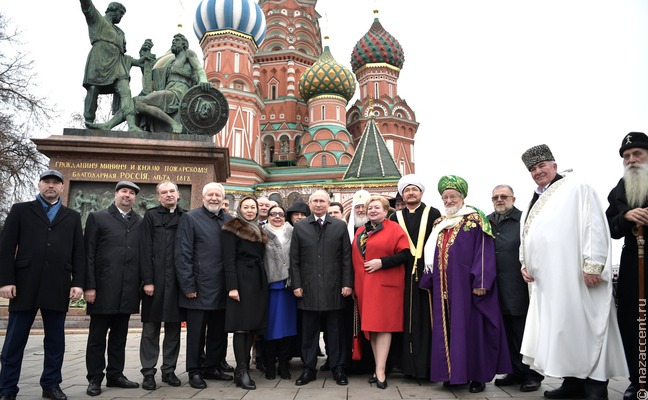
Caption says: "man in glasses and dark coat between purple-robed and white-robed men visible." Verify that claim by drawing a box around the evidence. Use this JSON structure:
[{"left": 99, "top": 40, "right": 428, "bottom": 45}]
[{"left": 488, "top": 185, "right": 544, "bottom": 392}]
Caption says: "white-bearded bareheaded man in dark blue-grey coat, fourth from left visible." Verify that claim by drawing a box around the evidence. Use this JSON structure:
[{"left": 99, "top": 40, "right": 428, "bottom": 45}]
[{"left": 175, "top": 182, "right": 233, "bottom": 389}]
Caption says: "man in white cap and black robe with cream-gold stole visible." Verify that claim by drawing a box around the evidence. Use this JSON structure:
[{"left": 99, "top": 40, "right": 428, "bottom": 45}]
[{"left": 389, "top": 174, "right": 441, "bottom": 379}]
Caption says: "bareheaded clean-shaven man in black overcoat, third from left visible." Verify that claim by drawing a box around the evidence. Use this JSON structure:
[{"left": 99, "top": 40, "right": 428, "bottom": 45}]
[{"left": 139, "top": 181, "right": 186, "bottom": 390}]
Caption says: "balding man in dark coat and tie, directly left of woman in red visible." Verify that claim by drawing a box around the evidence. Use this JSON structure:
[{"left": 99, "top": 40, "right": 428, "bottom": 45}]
[{"left": 290, "top": 190, "right": 353, "bottom": 386}]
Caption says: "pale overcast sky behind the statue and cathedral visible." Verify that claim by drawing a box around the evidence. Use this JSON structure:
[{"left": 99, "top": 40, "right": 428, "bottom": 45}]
[{"left": 0, "top": 0, "right": 648, "bottom": 260}]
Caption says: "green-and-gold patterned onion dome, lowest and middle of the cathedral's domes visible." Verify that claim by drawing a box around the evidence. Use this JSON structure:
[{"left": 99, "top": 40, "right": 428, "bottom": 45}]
[{"left": 299, "top": 46, "right": 356, "bottom": 102}]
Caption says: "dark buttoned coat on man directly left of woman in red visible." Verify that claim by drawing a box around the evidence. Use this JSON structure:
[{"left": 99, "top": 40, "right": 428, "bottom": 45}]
[{"left": 290, "top": 215, "right": 353, "bottom": 311}]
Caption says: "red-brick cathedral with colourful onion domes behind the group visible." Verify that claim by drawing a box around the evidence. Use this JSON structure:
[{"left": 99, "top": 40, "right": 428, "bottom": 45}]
[{"left": 194, "top": 0, "right": 418, "bottom": 212}]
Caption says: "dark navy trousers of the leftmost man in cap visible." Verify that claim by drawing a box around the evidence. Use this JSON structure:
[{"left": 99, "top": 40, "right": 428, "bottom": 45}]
[{"left": 0, "top": 309, "right": 65, "bottom": 396}]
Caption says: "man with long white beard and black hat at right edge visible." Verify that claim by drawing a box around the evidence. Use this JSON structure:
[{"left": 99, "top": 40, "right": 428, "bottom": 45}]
[{"left": 605, "top": 132, "right": 648, "bottom": 400}]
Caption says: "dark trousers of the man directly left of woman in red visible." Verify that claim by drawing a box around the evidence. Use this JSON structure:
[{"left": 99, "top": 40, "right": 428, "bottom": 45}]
[{"left": 301, "top": 309, "right": 346, "bottom": 371}]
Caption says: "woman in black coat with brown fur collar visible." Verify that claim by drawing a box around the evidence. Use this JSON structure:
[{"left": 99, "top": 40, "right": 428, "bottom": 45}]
[{"left": 221, "top": 196, "right": 268, "bottom": 390}]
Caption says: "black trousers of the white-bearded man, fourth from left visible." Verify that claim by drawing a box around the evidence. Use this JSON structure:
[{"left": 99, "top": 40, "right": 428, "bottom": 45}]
[{"left": 187, "top": 309, "right": 227, "bottom": 376}]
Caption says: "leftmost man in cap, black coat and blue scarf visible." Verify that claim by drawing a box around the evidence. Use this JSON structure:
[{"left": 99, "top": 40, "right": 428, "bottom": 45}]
[{"left": 0, "top": 170, "right": 85, "bottom": 400}]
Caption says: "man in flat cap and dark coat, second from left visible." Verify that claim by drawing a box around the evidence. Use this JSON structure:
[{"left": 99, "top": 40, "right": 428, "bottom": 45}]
[{"left": 84, "top": 181, "right": 142, "bottom": 396}]
